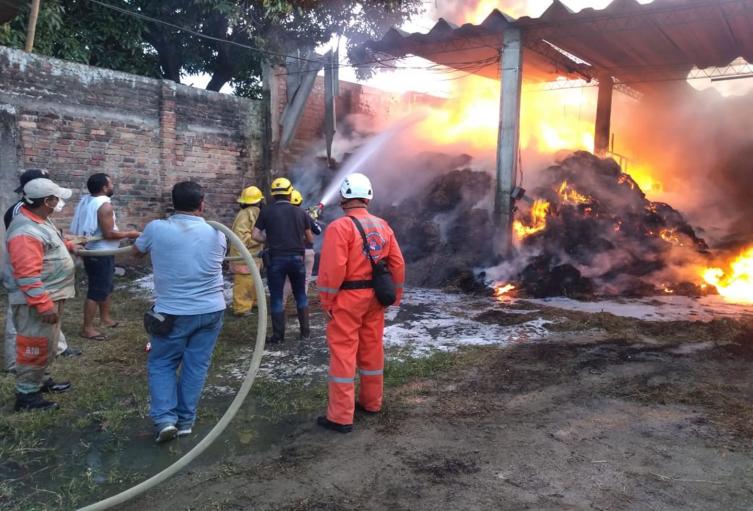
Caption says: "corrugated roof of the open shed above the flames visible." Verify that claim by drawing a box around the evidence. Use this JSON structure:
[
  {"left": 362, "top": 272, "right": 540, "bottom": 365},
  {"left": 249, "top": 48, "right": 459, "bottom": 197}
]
[{"left": 366, "top": 0, "right": 753, "bottom": 88}]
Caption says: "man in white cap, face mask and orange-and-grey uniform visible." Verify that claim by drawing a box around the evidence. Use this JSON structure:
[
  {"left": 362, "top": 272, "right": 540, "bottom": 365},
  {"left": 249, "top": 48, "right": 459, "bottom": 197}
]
[{"left": 3, "top": 178, "right": 77, "bottom": 411}]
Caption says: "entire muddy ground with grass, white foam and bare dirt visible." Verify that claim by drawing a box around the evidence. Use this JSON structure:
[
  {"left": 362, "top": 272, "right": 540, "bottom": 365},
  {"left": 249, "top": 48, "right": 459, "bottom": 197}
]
[{"left": 0, "top": 282, "right": 753, "bottom": 510}]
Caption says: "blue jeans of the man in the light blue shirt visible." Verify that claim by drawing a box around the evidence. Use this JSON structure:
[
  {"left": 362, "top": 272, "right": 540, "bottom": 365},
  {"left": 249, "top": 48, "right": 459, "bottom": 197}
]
[{"left": 147, "top": 311, "right": 224, "bottom": 431}]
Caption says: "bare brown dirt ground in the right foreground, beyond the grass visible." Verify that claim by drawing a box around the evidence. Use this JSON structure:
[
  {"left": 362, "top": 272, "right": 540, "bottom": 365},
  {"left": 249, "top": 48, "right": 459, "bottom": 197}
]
[{"left": 121, "top": 314, "right": 753, "bottom": 511}]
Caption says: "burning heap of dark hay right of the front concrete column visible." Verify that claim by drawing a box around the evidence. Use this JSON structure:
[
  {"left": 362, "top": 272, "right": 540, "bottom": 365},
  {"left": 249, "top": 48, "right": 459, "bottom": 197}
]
[{"left": 511, "top": 152, "right": 708, "bottom": 298}]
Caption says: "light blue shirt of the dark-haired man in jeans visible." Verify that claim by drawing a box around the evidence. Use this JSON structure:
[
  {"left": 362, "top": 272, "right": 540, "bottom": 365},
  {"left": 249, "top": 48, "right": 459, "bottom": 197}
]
[{"left": 135, "top": 213, "right": 227, "bottom": 316}]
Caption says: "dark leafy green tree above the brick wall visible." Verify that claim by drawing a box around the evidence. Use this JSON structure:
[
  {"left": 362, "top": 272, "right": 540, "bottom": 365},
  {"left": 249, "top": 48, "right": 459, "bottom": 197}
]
[{"left": 0, "top": 0, "right": 423, "bottom": 96}]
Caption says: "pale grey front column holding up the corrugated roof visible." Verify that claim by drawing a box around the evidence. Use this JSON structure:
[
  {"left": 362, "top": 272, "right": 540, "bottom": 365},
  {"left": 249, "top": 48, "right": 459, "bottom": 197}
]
[{"left": 494, "top": 27, "right": 523, "bottom": 256}]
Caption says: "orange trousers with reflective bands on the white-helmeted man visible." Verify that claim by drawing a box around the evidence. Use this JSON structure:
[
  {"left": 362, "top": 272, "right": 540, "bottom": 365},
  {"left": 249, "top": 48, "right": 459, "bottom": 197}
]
[{"left": 327, "top": 289, "right": 384, "bottom": 424}]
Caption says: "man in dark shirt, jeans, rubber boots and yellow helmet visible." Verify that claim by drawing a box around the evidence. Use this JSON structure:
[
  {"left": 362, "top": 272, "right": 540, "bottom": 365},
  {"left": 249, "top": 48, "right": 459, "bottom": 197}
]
[{"left": 253, "top": 177, "right": 314, "bottom": 344}]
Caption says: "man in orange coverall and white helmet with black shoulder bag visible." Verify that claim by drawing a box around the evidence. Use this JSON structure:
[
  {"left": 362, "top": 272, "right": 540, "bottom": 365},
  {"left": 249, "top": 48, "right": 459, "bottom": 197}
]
[{"left": 317, "top": 173, "right": 405, "bottom": 433}]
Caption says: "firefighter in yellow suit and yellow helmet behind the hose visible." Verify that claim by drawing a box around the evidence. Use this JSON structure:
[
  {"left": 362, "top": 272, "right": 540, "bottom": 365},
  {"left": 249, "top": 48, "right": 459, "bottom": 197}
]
[{"left": 230, "top": 186, "right": 264, "bottom": 316}]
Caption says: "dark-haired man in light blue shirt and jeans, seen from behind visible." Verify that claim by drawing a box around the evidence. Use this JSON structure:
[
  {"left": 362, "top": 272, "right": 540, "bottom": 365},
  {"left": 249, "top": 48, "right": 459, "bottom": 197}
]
[{"left": 134, "top": 181, "right": 227, "bottom": 443}]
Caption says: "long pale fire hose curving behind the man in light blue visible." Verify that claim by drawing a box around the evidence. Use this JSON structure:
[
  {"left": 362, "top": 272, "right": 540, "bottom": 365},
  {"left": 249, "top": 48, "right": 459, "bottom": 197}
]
[{"left": 70, "top": 221, "right": 267, "bottom": 511}]
